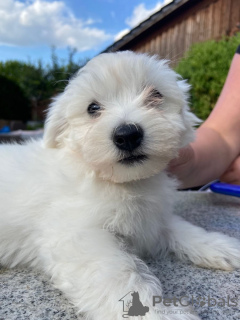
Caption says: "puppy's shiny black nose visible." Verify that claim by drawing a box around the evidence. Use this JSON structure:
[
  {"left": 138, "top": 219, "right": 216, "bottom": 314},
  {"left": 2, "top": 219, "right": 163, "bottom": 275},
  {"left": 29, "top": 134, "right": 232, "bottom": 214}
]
[{"left": 113, "top": 124, "right": 143, "bottom": 151}]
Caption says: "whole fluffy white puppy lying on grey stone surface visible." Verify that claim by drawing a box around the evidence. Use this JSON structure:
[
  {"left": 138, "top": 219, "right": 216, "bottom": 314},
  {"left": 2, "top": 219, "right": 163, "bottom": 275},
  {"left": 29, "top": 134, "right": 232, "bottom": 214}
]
[{"left": 0, "top": 52, "right": 240, "bottom": 320}]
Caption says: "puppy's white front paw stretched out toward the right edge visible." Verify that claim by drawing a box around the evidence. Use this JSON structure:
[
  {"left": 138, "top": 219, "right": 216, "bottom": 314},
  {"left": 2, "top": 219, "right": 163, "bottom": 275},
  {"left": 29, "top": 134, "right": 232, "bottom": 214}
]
[{"left": 169, "top": 216, "right": 240, "bottom": 270}]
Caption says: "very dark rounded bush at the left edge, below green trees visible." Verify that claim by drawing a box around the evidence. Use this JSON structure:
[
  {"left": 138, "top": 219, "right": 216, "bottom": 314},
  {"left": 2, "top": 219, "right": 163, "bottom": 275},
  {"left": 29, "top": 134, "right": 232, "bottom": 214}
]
[{"left": 0, "top": 75, "right": 31, "bottom": 122}]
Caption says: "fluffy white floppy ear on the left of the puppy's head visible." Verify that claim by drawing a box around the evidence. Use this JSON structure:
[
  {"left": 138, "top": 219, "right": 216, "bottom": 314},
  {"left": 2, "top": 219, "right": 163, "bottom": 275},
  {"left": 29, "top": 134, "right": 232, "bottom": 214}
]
[{"left": 43, "top": 95, "right": 68, "bottom": 148}]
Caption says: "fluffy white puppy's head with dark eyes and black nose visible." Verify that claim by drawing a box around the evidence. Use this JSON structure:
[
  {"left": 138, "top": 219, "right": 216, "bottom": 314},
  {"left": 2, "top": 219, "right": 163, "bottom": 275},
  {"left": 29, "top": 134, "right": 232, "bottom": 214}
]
[{"left": 44, "top": 51, "right": 197, "bottom": 182}]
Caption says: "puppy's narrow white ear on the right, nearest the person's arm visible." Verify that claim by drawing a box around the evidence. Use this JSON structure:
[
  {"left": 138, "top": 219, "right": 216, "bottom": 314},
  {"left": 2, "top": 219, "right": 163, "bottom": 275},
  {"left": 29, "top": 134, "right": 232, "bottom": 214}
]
[{"left": 178, "top": 80, "right": 202, "bottom": 148}]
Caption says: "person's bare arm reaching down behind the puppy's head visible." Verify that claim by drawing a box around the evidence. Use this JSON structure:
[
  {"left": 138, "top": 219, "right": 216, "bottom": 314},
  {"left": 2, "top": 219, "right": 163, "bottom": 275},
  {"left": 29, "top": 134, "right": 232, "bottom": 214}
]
[{"left": 169, "top": 54, "right": 240, "bottom": 188}]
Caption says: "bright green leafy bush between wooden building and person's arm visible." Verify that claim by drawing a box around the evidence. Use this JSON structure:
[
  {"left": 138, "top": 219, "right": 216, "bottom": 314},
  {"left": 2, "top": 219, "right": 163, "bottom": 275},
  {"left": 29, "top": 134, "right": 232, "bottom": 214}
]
[{"left": 175, "top": 34, "right": 240, "bottom": 120}]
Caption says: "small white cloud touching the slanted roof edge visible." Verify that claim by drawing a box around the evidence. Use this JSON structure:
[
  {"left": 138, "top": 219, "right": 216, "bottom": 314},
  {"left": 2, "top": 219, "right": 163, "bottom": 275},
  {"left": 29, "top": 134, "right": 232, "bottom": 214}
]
[{"left": 125, "top": 0, "right": 172, "bottom": 28}]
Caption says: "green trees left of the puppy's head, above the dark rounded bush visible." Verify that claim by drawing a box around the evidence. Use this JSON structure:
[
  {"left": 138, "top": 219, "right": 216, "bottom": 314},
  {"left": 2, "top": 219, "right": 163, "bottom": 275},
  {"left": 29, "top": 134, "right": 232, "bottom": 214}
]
[{"left": 0, "top": 47, "right": 85, "bottom": 120}]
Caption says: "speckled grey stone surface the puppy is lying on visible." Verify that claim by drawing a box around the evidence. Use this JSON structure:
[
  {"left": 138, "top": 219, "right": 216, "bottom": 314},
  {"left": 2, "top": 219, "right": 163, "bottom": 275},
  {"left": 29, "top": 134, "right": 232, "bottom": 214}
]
[{"left": 0, "top": 192, "right": 240, "bottom": 320}]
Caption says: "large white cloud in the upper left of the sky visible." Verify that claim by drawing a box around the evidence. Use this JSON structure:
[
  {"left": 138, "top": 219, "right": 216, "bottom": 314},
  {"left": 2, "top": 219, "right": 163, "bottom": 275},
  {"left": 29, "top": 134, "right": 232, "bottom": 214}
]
[{"left": 0, "top": 0, "right": 111, "bottom": 51}]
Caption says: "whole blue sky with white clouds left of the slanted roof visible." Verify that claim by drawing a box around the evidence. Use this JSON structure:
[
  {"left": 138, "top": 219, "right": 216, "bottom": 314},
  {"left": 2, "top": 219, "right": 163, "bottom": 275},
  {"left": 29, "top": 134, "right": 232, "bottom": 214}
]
[{"left": 0, "top": 0, "right": 171, "bottom": 63}]
